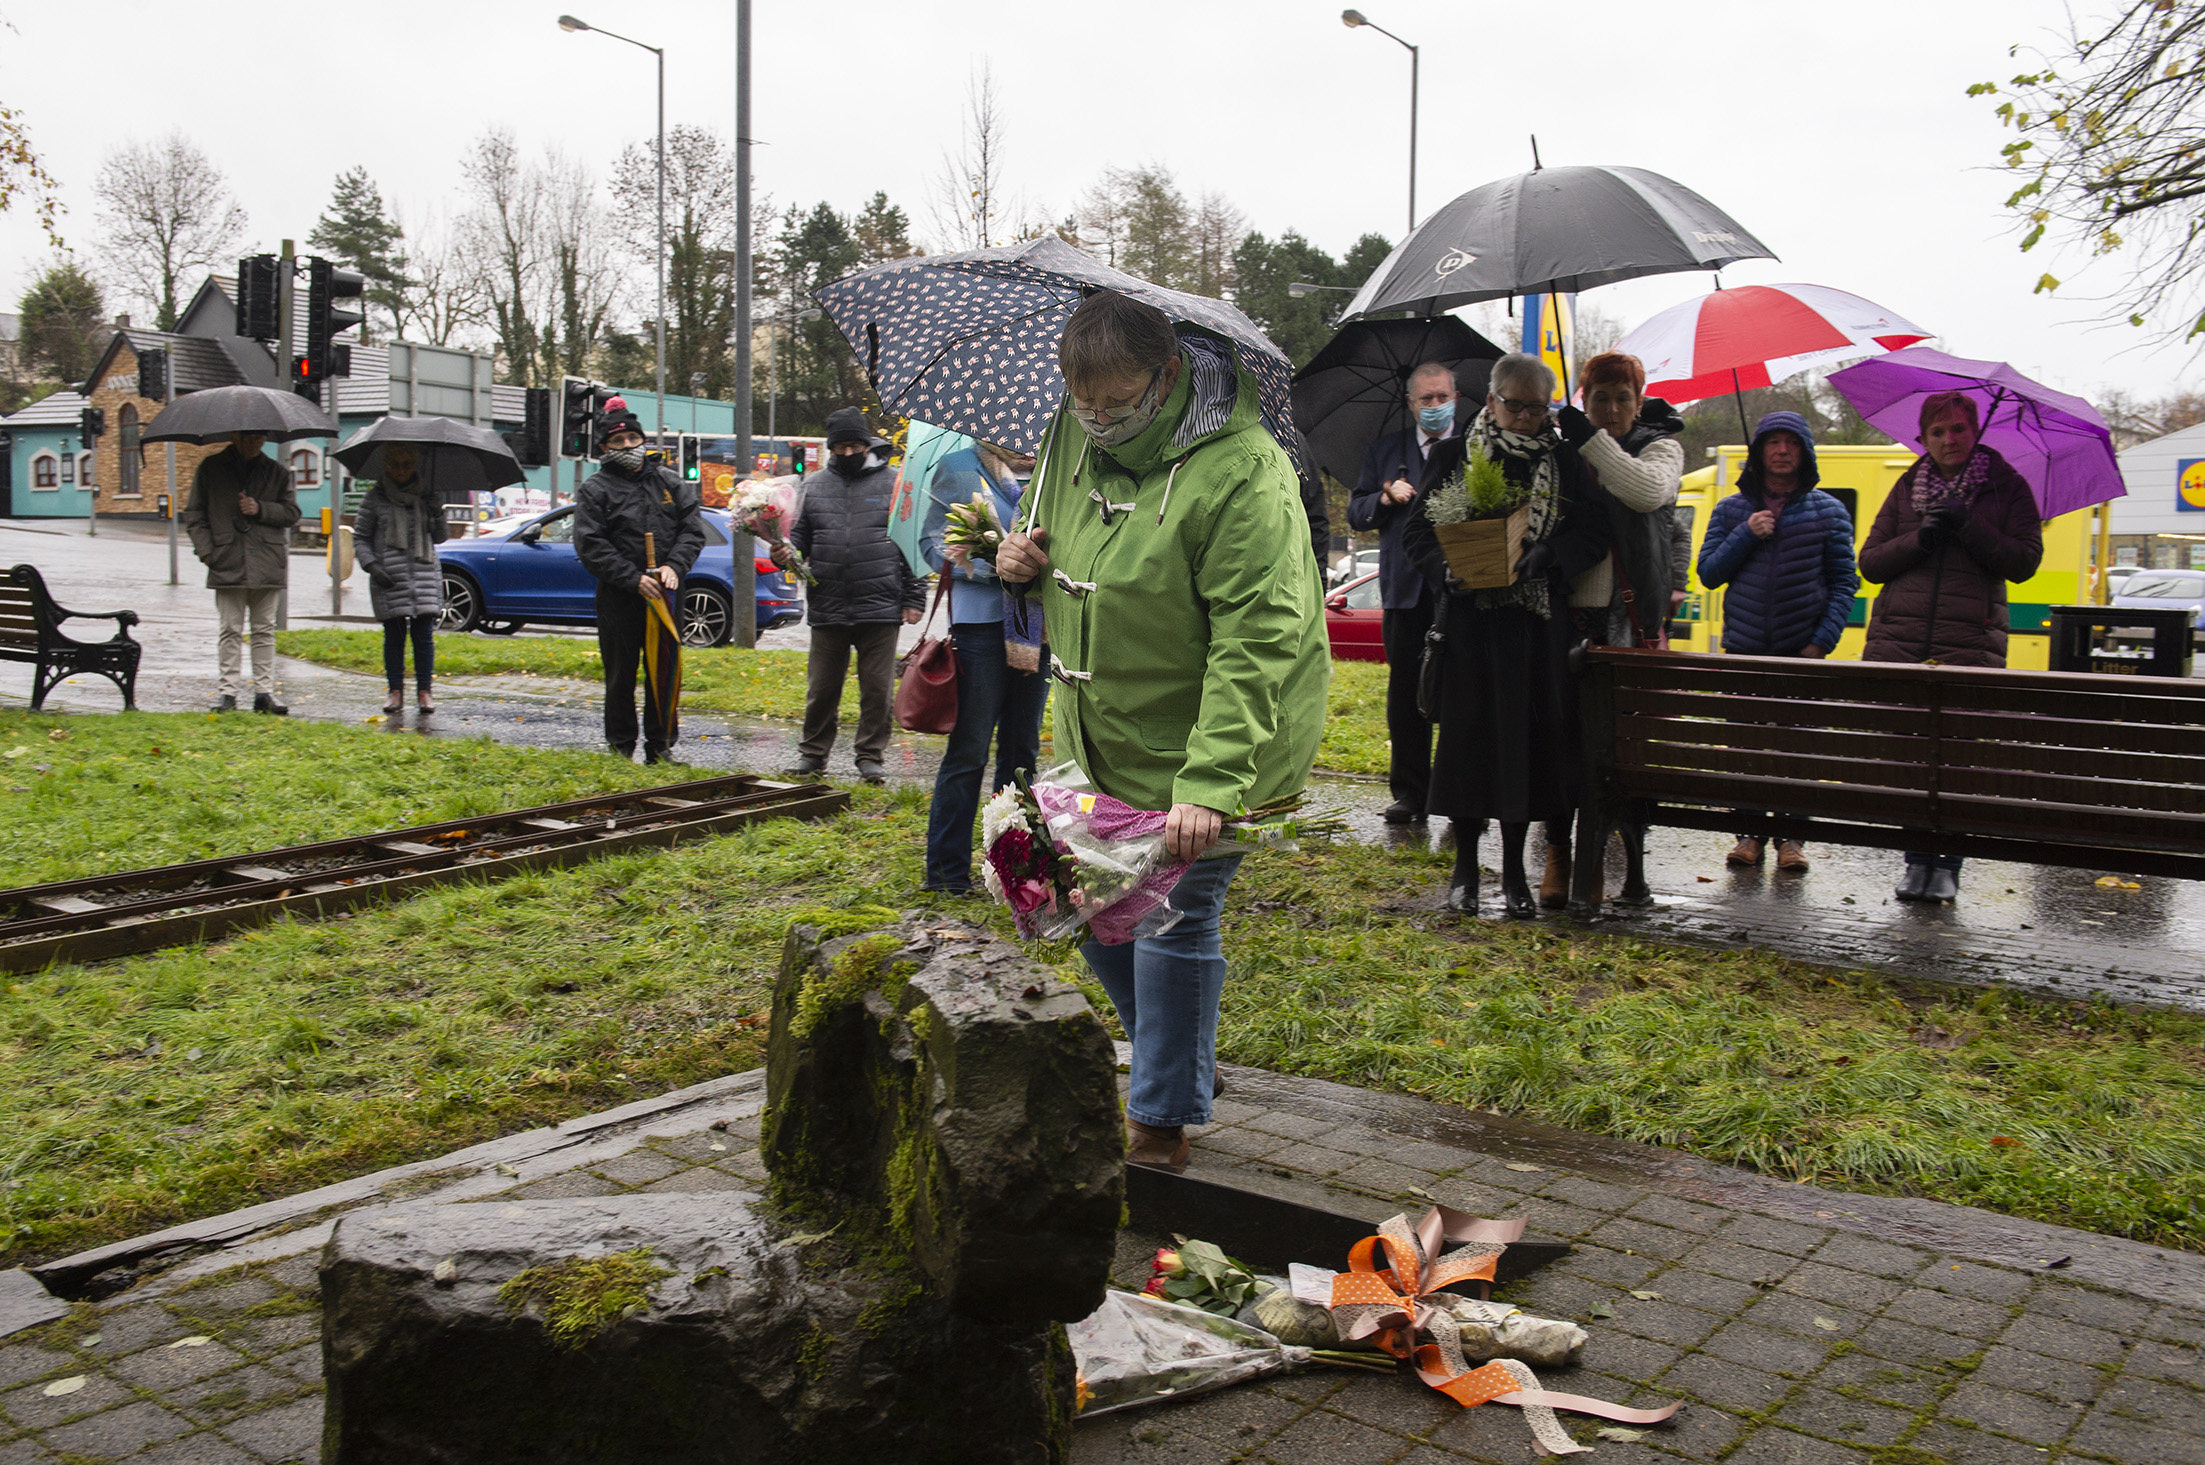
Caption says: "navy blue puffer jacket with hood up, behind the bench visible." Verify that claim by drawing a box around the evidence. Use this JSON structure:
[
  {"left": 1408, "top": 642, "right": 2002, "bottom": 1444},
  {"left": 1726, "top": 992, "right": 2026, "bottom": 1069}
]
[{"left": 1700, "top": 421, "right": 1861, "bottom": 655}]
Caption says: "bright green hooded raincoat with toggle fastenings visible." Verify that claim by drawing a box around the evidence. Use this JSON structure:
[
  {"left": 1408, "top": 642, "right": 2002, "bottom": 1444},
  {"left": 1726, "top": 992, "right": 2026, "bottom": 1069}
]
[{"left": 1032, "top": 344, "right": 1332, "bottom": 814}]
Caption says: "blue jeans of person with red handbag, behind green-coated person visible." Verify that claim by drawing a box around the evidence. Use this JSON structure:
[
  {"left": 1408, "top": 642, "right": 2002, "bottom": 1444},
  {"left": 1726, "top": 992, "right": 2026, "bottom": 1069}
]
[{"left": 926, "top": 620, "right": 1050, "bottom": 891}]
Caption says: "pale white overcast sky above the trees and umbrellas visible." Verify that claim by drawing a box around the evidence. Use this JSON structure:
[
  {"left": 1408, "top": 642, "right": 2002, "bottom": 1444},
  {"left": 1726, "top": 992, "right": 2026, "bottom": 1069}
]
[{"left": 0, "top": 0, "right": 2205, "bottom": 395}]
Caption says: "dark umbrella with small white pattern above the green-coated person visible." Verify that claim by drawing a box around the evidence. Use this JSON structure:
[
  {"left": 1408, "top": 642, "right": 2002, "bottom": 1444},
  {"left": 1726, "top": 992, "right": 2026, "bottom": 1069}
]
[{"left": 816, "top": 238, "right": 1305, "bottom": 468}]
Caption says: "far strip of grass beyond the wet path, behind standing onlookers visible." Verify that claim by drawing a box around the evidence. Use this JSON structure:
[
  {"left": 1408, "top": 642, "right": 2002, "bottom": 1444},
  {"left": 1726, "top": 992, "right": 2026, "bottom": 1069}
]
[{"left": 276, "top": 631, "right": 1387, "bottom": 777}]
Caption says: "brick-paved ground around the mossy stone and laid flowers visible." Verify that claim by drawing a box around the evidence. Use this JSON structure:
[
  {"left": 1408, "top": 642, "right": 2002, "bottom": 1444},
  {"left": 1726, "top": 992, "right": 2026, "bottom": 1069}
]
[{"left": 0, "top": 1070, "right": 2205, "bottom": 1465}]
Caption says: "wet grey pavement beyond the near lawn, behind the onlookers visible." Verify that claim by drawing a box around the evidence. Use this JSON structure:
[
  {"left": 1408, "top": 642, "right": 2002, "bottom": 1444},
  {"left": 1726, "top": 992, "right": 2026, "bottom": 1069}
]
[{"left": 0, "top": 521, "right": 2205, "bottom": 1010}]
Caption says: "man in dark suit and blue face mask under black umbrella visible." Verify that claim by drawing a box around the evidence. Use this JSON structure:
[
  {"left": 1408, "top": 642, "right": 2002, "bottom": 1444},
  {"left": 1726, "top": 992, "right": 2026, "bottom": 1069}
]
[{"left": 1347, "top": 362, "right": 1455, "bottom": 823}]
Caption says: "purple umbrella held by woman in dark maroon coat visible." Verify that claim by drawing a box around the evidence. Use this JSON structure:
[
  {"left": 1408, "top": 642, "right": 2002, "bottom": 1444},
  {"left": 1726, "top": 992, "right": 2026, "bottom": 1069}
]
[{"left": 1830, "top": 346, "right": 2128, "bottom": 518}]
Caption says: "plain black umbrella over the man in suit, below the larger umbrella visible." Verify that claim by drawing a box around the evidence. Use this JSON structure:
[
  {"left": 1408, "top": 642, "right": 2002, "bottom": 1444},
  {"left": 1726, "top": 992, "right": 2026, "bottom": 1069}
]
[{"left": 1294, "top": 316, "right": 1506, "bottom": 485}]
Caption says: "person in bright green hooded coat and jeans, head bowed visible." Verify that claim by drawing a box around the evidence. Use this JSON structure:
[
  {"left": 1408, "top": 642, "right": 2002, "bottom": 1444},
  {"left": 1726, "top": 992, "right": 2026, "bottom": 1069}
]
[{"left": 997, "top": 291, "right": 1332, "bottom": 1169}]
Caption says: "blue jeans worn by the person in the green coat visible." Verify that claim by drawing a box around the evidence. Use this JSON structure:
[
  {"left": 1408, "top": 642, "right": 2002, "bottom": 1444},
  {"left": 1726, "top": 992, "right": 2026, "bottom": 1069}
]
[{"left": 1080, "top": 854, "right": 1244, "bottom": 1130}]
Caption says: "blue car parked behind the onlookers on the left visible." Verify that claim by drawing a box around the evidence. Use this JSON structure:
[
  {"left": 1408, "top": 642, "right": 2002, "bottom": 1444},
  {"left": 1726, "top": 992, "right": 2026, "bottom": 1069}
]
[{"left": 437, "top": 503, "right": 805, "bottom": 646}]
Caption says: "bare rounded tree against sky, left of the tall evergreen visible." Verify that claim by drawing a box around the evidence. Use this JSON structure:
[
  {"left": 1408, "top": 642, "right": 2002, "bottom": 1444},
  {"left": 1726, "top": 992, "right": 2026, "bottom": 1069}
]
[{"left": 93, "top": 132, "right": 245, "bottom": 331}]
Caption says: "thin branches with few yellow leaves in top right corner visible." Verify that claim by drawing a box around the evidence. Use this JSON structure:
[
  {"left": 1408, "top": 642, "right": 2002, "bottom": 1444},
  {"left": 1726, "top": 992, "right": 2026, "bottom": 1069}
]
[{"left": 1967, "top": 0, "right": 2205, "bottom": 338}]
